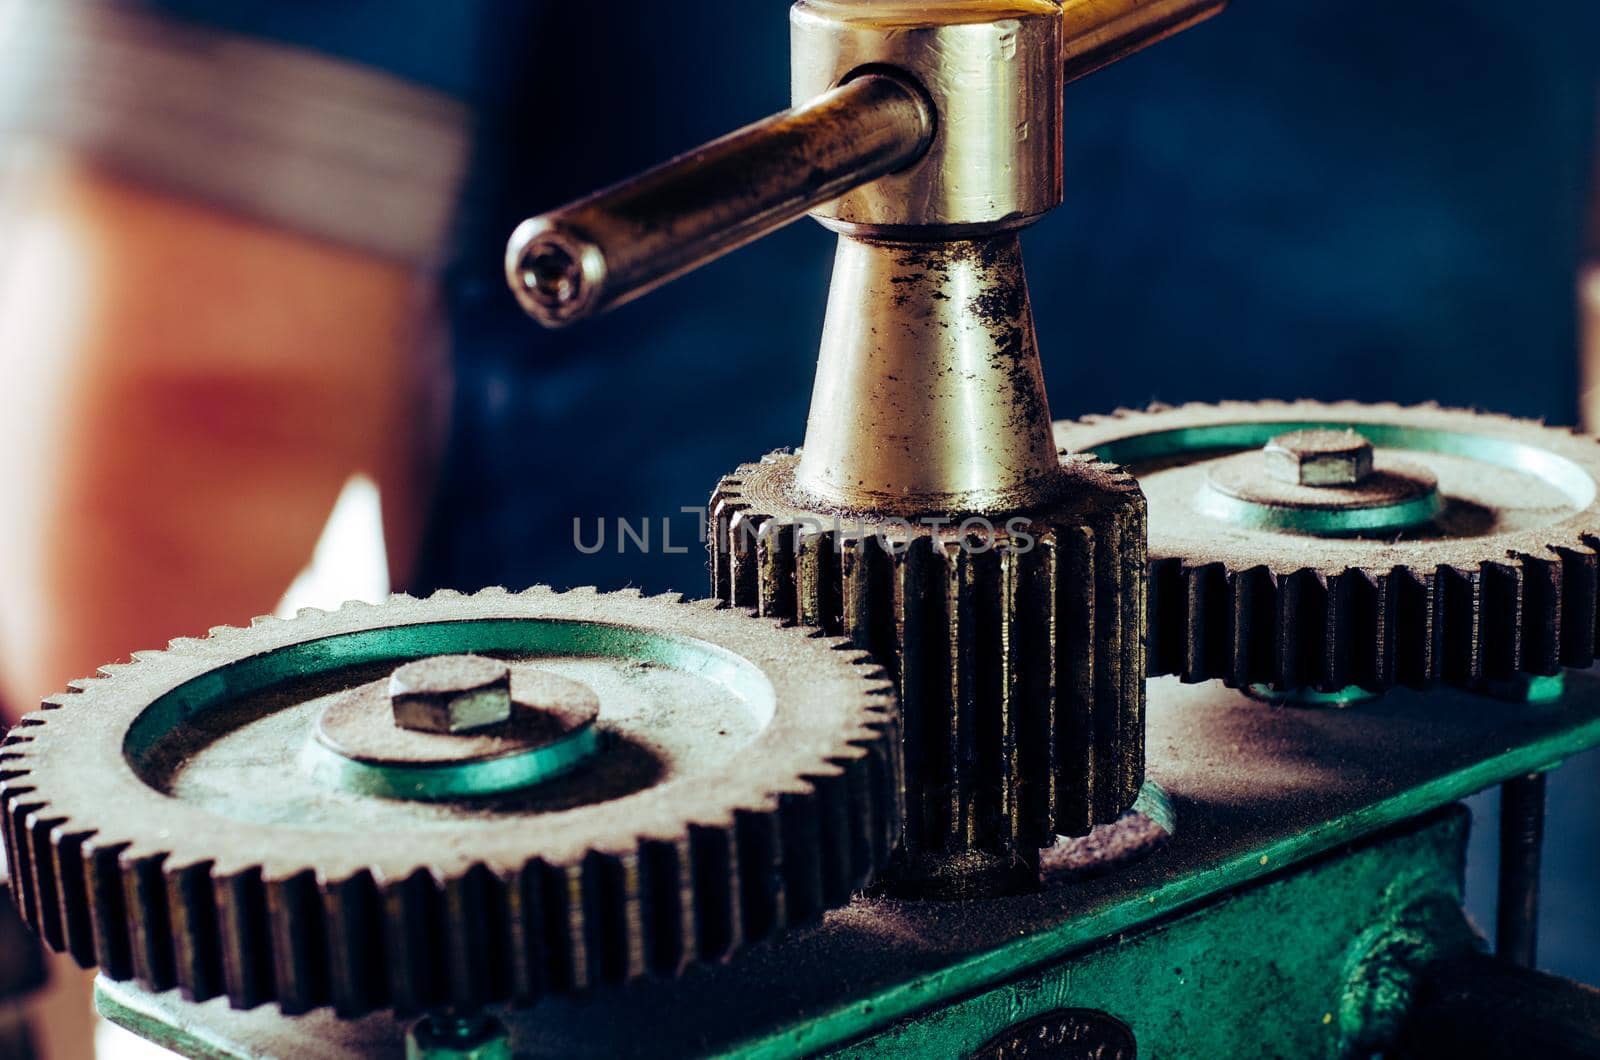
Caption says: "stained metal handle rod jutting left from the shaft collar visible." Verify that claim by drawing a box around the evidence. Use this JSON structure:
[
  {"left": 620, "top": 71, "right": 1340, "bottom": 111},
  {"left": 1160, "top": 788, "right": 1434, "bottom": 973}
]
[{"left": 506, "top": 74, "right": 934, "bottom": 327}]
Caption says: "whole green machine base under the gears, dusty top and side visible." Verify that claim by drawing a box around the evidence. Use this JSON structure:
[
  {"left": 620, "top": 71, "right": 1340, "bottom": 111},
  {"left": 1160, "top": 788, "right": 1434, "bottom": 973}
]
[{"left": 98, "top": 673, "right": 1600, "bottom": 1058}]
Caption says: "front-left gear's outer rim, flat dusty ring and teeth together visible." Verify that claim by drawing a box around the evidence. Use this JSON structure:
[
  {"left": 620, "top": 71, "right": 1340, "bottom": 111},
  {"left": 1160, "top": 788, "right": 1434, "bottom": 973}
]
[{"left": 0, "top": 589, "right": 901, "bottom": 1017}]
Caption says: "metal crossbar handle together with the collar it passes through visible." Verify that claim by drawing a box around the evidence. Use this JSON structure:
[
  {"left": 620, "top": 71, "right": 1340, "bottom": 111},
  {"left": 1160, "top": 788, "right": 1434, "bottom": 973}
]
[{"left": 506, "top": 0, "right": 1226, "bottom": 327}]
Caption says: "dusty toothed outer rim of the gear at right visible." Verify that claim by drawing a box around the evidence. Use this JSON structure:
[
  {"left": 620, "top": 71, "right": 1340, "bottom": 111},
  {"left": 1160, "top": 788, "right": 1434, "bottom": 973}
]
[{"left": 1056, "top": 400, "right": 1600, "bottom": 692}]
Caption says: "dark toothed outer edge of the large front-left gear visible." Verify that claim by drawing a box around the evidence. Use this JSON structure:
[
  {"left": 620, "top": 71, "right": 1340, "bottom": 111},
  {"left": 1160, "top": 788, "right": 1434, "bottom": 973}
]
[{"left": 0, "top": 589, "right": 901, "bottom": 1018}]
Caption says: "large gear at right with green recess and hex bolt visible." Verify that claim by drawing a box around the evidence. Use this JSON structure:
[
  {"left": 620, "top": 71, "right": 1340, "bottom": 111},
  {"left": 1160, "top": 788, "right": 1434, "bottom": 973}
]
[{"left": 1056, "top": 402, "right": 1600, "bottom": 692}]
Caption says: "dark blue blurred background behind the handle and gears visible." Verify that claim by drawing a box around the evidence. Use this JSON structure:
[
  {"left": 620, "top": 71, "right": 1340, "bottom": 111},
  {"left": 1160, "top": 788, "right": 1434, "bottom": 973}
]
[{"left": 168, "top": 0, "right": 1600, "bottom": 982}]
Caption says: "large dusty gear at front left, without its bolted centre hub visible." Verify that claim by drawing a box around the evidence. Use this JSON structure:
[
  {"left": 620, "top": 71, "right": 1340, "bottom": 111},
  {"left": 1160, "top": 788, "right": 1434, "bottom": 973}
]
[{"left": 0, "top": 589, "right": 899, "bottom": 1017}]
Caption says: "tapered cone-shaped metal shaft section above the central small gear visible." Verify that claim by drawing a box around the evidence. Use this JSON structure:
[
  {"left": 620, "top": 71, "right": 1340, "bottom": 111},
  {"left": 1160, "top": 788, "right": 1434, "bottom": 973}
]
[{"left": 794, "top": 234, "right": 1072, "bottom": 517}]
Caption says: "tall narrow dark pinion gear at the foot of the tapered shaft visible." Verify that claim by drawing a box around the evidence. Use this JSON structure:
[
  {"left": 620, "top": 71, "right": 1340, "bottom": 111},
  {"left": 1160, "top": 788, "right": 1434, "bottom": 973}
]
[{"left": 710, "top": 453, "right": 1146, "bottom": 897}]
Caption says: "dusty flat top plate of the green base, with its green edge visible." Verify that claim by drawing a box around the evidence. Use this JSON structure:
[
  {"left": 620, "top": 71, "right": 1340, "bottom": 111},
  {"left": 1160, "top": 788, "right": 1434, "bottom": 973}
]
[{"left": 96, "top": 673, "right": 1600, "bottom": 1058}]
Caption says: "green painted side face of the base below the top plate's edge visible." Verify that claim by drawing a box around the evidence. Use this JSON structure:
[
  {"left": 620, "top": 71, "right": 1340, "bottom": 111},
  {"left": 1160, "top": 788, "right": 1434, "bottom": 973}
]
[{"left": 829, "top": 805, "right": 1467, "bottom": 1060}]
